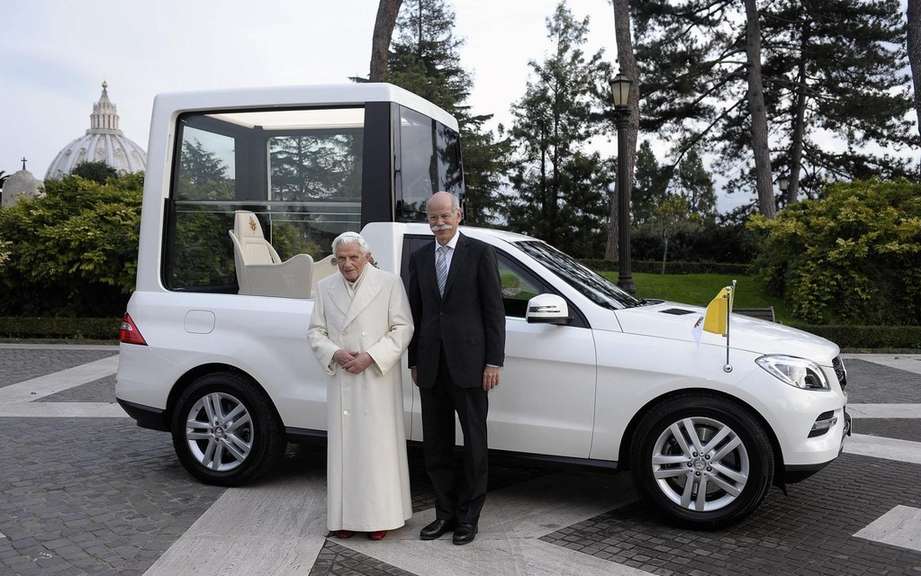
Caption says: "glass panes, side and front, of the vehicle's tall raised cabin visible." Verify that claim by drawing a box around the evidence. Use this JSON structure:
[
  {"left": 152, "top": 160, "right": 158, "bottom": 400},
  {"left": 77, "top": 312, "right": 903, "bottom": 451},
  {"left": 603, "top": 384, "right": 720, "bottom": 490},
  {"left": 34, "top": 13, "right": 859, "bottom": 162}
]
[{"left": 161, "top": 102, "right": 464, "bottom": 293}]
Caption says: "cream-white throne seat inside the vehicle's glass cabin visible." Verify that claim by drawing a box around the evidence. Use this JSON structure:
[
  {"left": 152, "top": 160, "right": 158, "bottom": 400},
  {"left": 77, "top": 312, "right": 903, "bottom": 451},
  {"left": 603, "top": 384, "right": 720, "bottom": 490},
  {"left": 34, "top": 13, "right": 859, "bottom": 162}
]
[{"left": 227, "top": 210, "right": 313, "bottom": 298}]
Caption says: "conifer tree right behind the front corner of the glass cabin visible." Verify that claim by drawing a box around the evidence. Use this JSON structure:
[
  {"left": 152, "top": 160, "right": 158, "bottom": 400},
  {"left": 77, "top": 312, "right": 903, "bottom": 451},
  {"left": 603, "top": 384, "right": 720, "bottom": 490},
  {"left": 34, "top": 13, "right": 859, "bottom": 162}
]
[{"left": 388, "top": 0, "right": 510, "bottom": 225}]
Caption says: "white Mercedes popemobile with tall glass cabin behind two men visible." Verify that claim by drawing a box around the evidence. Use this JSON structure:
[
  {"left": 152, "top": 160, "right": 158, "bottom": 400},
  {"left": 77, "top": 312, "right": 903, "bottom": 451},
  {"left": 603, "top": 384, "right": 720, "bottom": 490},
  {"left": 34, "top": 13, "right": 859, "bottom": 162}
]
[{"left": 116, "top": 84, "right": 850, "bottom": 526}]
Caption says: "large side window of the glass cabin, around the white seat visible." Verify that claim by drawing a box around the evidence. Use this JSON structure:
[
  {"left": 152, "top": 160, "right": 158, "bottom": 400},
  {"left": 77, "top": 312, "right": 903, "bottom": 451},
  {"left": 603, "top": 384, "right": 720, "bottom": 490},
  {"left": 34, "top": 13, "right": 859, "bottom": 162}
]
[{"left": 162, "top": 107, "right": 365, "bottom": 293}]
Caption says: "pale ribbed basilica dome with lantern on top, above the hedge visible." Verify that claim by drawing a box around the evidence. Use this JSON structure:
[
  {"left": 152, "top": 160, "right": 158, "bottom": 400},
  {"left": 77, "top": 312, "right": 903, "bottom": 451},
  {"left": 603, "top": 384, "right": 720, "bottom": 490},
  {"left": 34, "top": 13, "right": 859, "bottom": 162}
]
[{"left": 45, "top": 82, "right": 147, "bottom": 180}]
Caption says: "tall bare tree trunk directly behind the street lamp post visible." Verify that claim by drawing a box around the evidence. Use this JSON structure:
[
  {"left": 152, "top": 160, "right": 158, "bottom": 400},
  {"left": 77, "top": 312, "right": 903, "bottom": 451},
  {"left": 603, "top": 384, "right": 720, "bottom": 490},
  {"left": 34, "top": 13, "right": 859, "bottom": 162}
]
[{"left": 604, "top": 0, "right": 640, "bottom": 260}]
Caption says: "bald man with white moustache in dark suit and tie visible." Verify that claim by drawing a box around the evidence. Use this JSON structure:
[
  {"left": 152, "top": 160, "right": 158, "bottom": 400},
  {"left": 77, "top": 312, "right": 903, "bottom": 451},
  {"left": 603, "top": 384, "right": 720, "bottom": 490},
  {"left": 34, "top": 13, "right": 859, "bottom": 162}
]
[{"left": 407, "top": 192, "right": 505, "bottom": 544}]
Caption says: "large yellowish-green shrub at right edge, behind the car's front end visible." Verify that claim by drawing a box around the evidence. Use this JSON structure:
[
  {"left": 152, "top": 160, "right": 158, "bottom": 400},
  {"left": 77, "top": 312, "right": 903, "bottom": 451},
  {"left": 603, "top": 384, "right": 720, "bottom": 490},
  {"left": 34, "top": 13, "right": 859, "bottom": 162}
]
[{"left": 750, "top": 180, "right": 921, "bottom": 325}]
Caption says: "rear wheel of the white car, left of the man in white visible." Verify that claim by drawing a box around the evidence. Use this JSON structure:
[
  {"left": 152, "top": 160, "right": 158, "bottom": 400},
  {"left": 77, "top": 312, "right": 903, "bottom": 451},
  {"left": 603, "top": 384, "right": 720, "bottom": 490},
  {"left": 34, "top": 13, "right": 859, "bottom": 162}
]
[{"left": 170, "top": 372, "right": 287, "bottom": 486}]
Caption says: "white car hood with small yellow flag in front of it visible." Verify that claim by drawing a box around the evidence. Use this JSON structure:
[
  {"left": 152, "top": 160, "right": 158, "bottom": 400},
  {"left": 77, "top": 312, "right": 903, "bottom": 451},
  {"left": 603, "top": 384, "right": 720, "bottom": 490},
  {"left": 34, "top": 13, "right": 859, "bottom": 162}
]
[{"left": 616, "top": 302, "right": 840, "bottom": 366}]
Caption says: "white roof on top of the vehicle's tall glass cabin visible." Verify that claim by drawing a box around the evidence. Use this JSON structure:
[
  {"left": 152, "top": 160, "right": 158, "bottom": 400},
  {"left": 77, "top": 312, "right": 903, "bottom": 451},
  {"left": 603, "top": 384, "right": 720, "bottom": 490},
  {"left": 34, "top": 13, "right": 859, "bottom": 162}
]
[{"left": 154, "top": 82, "right": 458, "bottom": 132}]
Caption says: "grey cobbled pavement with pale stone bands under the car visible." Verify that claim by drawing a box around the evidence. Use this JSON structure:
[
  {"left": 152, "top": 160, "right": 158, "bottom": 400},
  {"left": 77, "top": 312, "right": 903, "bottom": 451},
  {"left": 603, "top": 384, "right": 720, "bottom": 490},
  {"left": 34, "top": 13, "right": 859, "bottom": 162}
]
[{"left": 0, "top": 346, "right": 921, "bottom": 576}]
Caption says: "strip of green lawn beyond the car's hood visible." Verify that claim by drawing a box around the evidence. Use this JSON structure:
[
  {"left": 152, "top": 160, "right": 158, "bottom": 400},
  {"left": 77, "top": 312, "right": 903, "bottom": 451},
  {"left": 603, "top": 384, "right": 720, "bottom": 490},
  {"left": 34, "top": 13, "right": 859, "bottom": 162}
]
[{"left": 601, "top": 272, "right": 793, "bottom": 324}]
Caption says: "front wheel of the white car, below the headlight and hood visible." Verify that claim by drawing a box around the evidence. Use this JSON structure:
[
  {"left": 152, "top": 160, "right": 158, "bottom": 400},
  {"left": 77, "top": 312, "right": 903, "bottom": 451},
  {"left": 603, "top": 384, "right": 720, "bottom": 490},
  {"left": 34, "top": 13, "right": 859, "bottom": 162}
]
[{"left": 630, "top": 394, "right": 774, "bottom": 529}]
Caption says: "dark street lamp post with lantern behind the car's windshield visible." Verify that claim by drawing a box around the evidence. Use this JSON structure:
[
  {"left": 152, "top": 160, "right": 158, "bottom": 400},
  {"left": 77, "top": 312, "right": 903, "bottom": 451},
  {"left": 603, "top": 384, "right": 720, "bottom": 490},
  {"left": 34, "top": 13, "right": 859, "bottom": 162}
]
[{"left": 610, "top": 74, "right": 636, "bottom": 294}]
